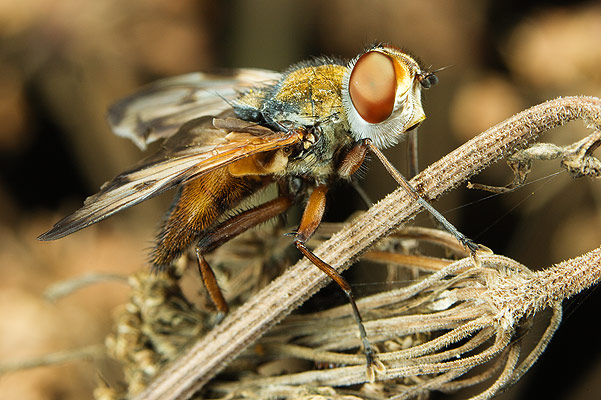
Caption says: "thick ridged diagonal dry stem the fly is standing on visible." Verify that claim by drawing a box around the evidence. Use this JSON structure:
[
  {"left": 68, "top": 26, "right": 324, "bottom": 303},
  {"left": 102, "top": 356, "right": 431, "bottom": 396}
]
[{"left": 136, "top": 97, "right": 601, "bottom": 400}]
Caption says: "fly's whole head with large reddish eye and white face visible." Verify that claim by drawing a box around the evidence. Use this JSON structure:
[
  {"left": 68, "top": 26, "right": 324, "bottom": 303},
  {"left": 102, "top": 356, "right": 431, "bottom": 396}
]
[{"left": 342, "top": 46, "right": 438, "bottom": 148}]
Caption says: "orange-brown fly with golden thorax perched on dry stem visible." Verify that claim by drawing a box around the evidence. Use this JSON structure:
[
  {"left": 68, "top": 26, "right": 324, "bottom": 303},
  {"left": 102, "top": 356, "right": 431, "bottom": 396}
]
[{"left": 39, "top": 45, "right": 479, "bottom": 380}]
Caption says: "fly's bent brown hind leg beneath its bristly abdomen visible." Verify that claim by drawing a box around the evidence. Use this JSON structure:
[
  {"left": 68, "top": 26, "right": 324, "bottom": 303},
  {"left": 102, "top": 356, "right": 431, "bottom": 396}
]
[{"left": 196, "top": 196, "right": 292, "bottom": 323}]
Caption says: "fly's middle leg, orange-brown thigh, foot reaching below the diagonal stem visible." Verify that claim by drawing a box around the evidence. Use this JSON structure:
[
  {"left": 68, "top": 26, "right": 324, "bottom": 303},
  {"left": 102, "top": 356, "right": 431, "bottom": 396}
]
[{"left": 294, "top": 185, "right": 383, "bottom": 381}]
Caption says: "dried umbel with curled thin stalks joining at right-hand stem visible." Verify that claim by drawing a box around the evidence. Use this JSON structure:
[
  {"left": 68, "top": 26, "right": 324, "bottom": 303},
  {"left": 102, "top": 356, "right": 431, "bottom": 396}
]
[{"left": 211, "top": 248, "right": 601, "bottom": 399}]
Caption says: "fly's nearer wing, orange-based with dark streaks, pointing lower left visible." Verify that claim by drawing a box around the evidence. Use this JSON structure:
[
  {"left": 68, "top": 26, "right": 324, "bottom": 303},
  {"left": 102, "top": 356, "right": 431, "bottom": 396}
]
[{"left": 38, "top": 117, "right": 302, "bottom": 240}]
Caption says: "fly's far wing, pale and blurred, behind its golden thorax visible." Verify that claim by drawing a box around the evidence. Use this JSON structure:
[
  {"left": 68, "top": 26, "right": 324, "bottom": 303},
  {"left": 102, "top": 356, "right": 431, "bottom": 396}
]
[{"left": 108, "top": 69, "right": 281, "bottom": 150}]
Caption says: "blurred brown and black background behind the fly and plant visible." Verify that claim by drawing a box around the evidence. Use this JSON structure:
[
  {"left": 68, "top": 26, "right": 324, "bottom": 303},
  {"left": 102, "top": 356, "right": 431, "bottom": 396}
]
[{"left": 0, "top": 0, "right": 601, "bottom": 399}]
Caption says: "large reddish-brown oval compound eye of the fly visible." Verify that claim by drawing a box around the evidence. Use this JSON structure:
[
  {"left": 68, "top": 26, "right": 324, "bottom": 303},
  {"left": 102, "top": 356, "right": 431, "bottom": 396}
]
[{"left": 349, "top": 51, "right": 397, "bottom": 124}]
